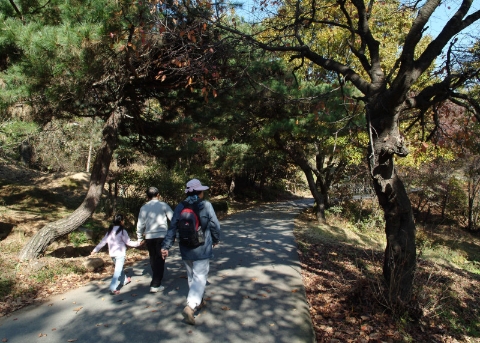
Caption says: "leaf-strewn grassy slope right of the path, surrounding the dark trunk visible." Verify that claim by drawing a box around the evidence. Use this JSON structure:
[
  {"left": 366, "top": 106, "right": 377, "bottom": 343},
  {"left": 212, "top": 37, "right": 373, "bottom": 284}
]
[{"left": 295, "top": 208, "right": 480, "bottom": 342}]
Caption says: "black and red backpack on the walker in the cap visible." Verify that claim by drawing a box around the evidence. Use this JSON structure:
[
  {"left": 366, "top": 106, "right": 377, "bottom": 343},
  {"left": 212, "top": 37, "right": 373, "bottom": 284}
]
[{"left": 177, "top": 201, "right": 205, "bottom": 248}]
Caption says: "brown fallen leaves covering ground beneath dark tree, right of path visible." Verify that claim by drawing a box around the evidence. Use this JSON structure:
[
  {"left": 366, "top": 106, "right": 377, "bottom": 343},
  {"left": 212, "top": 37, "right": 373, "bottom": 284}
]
[{"left": 293, "top": 214, "right": 480, "bottom": 343}]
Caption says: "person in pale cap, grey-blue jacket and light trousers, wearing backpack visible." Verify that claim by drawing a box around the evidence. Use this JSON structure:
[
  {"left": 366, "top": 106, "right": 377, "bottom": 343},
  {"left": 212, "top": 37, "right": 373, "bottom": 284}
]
[{"left": 161, "top": 179, "right": 220, "bottom": 325}]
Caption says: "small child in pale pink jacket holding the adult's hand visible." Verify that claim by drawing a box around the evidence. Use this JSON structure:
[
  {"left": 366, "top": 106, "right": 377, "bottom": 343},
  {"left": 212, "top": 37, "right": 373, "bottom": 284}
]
[{"left": 90, "top": 214, "right": 143, "bottom": 295}]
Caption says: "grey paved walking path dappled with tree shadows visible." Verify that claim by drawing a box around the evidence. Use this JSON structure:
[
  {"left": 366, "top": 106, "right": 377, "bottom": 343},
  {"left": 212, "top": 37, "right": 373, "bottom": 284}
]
[{"left": 0, "top": 199, "right": 315, "bottom": 343}]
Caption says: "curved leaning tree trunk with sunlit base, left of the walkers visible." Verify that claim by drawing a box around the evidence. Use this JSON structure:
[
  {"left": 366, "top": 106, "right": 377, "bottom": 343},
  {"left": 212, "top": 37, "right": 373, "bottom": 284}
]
[{"left": 19, "top": 111, "right": 120, "bottom": 260}]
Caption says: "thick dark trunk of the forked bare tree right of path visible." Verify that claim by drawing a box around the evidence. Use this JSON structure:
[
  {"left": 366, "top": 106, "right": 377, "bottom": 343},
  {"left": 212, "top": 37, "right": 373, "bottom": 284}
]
[{"left": 367, "top": 109, "right": 416, "bottom": 306}]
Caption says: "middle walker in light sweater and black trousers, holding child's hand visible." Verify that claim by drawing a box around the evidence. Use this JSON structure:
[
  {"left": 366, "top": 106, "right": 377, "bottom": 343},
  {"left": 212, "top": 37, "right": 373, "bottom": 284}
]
[{"left": 137, "top": 187, "right": 173, "bottom": 293}]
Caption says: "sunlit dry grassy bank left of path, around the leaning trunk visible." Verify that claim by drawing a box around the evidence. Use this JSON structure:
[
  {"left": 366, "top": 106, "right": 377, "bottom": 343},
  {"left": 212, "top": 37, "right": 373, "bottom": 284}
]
[{"left": 0, "top": 161, "right": 148, "bottom": 316}]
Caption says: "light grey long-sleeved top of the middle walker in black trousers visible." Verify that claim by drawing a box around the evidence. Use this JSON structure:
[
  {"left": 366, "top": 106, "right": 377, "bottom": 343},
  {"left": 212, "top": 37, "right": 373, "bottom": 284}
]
[{"left": 137, "top": 199, "right": 173, "bottom": 240}]
